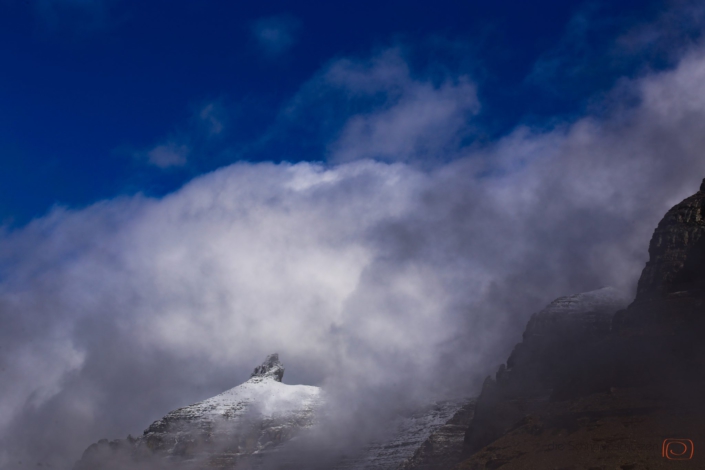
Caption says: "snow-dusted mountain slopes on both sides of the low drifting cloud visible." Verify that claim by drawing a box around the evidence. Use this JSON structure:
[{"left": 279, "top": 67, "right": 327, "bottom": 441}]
[{"left": 75, "top": 354, "right": 476, "bottom": 470}]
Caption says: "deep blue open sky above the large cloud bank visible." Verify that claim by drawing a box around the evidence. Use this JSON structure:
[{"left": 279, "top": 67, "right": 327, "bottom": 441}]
[{"left": 0, "top": 0, "right": 697, "bottom": 226}]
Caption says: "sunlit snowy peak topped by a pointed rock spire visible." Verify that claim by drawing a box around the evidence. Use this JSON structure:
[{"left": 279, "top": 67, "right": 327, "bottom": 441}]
[{"left": 75, "top": 354, "right": 321, "bottom": 470}]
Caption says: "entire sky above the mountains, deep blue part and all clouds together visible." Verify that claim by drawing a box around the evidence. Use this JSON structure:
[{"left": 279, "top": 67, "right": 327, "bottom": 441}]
[{"left": 6, "top": 0, "right": 705, "bottom": 470}]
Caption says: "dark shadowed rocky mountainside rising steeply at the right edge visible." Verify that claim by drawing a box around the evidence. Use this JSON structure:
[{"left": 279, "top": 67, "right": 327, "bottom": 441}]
[{"left": 457, "top": 178, "right": 705, "bottom": 470}]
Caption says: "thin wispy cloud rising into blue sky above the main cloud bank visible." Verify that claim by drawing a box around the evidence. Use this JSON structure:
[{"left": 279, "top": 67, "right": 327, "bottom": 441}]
[{"left": 284, "top": 48, "right": 480, "bottom": 165}]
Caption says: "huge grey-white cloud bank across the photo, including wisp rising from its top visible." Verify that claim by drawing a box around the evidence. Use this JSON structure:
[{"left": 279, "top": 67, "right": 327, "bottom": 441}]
[{"left": 0, "top": 35, "right": 705, "bottom": 468}]
